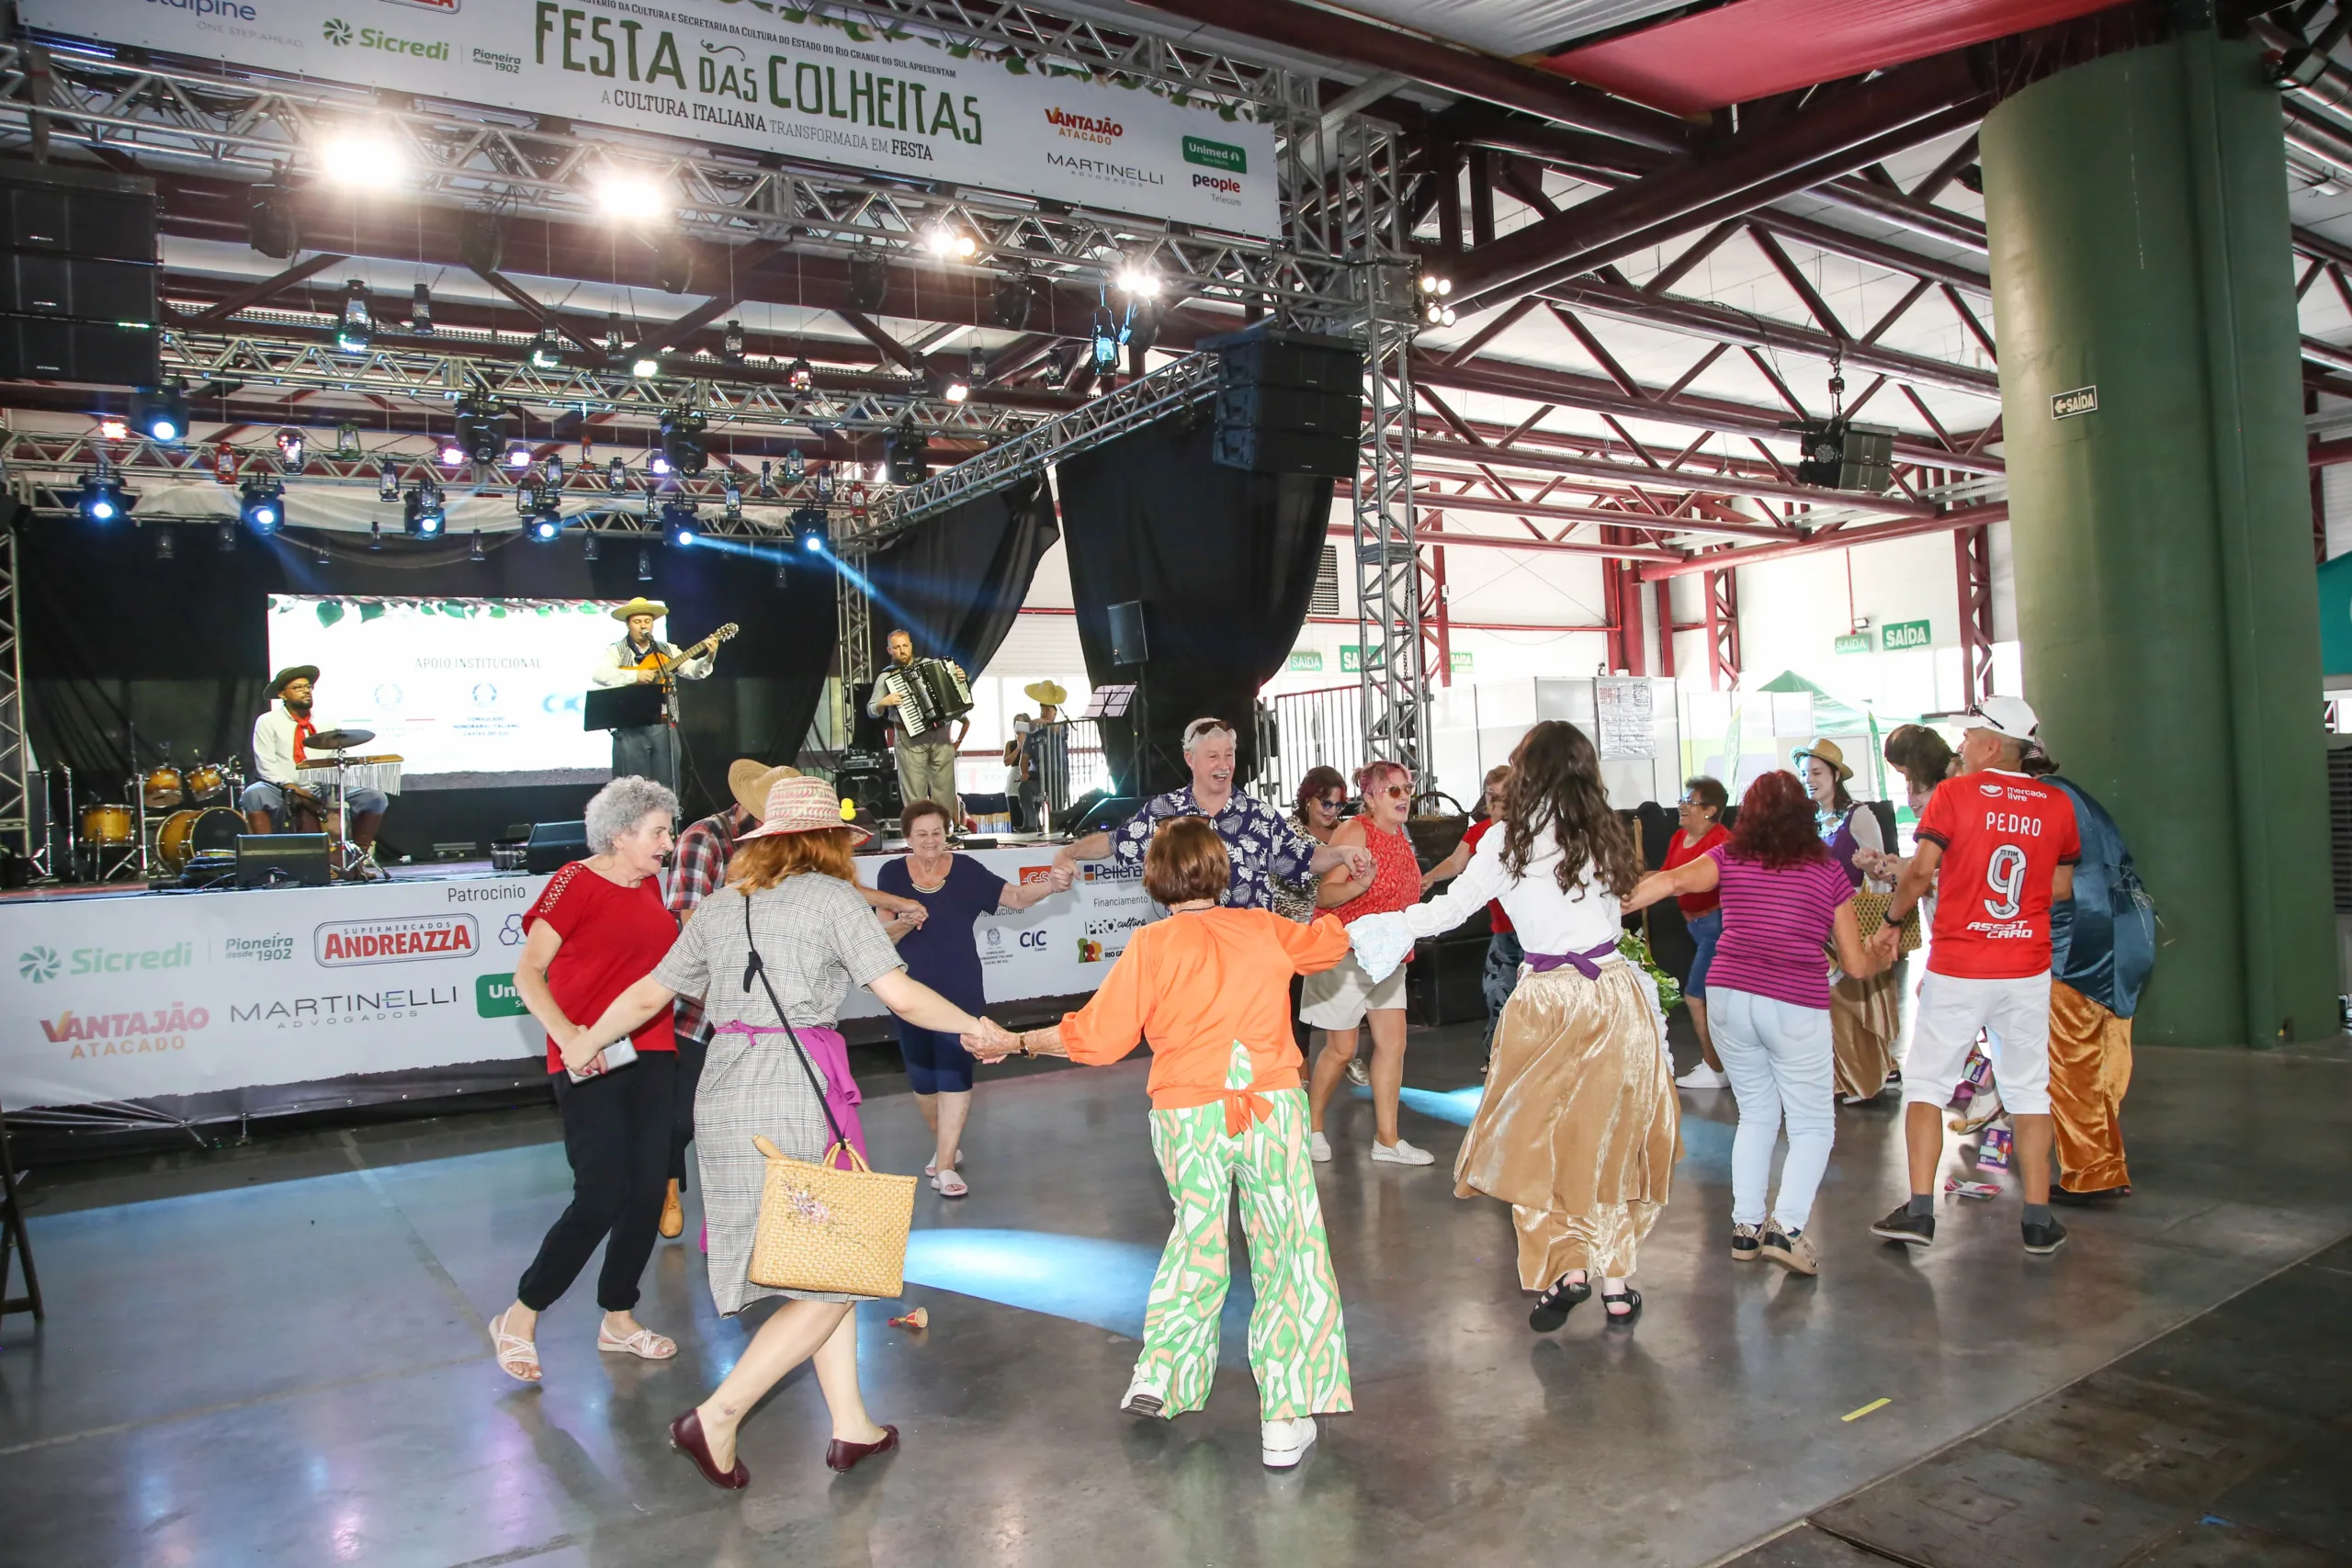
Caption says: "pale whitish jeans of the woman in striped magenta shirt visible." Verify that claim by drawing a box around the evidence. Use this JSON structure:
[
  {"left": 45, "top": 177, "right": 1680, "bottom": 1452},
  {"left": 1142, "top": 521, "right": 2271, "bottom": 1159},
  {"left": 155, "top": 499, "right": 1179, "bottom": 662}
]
[{"left": 1708, "top": 983, "right": 1837, "bottom": 1229}]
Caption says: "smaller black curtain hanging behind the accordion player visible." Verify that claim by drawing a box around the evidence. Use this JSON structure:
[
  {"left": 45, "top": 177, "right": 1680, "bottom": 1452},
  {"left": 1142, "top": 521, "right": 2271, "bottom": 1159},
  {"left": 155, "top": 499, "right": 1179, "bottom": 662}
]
[{"left": 856, "top": 478, "right": 1061, "bottom": 748}]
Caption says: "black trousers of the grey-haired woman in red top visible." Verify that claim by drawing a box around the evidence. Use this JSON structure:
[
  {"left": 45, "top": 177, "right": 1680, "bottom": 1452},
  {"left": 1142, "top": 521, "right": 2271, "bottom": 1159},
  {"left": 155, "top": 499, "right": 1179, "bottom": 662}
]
[{"left": 515, "top": 1051, "right": 677, "bottom": 1312}]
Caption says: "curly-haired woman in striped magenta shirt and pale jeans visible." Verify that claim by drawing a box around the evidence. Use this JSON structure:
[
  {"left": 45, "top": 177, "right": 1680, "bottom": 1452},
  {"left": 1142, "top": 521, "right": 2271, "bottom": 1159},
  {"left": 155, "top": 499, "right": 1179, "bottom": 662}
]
[{"left": 1625, "top": 771, "right": 1884, "bottom": 1274}]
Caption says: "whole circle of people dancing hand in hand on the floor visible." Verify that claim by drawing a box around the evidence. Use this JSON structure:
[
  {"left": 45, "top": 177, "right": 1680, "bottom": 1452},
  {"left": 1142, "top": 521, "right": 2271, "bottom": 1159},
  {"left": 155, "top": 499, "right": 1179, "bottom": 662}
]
[{"left": 489, "top": 698, "right": 2154, "bottom": 1491}]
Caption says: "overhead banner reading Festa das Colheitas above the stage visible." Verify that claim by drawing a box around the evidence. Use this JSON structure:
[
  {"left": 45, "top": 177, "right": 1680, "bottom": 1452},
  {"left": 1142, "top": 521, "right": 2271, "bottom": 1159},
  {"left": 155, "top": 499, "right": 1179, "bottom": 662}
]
[{"left": 17, "top": 0, "right": 1280, "bottom": 237}]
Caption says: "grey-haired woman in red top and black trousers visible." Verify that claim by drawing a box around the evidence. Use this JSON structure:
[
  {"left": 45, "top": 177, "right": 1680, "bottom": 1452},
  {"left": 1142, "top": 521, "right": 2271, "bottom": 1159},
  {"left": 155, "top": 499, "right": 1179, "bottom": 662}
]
[{"left": 489, "top": 778, "right": 677, "bottom": 1382}]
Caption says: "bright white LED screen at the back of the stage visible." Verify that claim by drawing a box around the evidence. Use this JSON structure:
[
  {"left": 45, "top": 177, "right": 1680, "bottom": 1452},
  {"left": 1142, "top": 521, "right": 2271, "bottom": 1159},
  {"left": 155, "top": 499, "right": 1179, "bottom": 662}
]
[{"left": 270, "top": 592, "right": 661, "bottom": 790}]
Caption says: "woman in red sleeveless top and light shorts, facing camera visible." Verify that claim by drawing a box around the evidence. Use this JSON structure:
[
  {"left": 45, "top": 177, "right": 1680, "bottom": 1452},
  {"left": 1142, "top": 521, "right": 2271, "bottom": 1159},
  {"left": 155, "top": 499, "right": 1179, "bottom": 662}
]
[{"left": 1298, "top": 761, "right": 1435, "bottom": 1166}]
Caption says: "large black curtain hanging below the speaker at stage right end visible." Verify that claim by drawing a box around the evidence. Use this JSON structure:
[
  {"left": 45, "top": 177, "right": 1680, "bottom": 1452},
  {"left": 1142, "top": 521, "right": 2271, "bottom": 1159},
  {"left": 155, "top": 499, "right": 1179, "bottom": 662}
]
[{"left": 1058, "top": 419, "right": 1331, "bottom": 795}]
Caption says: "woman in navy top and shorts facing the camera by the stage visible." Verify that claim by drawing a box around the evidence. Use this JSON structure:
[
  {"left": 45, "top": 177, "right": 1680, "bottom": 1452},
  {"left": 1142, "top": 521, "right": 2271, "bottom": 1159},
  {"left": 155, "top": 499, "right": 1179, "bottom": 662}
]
[{"left": 875, "top": 799, "right": 1070, "bottom": 1199}]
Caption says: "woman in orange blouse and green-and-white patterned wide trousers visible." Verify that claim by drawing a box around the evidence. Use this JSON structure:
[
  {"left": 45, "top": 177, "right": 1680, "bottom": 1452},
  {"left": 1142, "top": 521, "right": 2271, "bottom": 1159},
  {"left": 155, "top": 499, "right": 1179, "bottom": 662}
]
[{"left": 965, "top": 816, "right": 1355, "bottom": 1470}]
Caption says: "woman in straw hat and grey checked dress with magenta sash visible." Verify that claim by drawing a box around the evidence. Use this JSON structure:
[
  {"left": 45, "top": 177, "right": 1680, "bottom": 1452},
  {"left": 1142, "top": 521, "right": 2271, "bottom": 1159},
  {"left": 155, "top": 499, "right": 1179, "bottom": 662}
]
[{"left": 578, "top": 778, "right": 1011, "bottom": 1491}]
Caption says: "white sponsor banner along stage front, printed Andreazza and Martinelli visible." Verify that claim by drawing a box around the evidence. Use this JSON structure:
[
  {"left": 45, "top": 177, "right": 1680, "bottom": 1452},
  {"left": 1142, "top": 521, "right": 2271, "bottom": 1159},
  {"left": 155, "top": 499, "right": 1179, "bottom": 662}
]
[{"left": 0, "top": 849, "right": 1119, "bottom": 1110}]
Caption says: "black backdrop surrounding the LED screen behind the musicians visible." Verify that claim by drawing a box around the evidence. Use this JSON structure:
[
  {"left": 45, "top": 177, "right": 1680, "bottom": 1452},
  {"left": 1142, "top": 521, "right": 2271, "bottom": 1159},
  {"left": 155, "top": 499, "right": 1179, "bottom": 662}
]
[{"left": 17, "top": 520, "right": 835, "bottom": 858}]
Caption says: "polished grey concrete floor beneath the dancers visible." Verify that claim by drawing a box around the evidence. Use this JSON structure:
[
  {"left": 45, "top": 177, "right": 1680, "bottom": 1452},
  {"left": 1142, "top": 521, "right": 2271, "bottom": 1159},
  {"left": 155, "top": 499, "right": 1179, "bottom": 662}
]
[{"left": 0, "top": 1027, "right": 2352, "bottom": 1568}]
